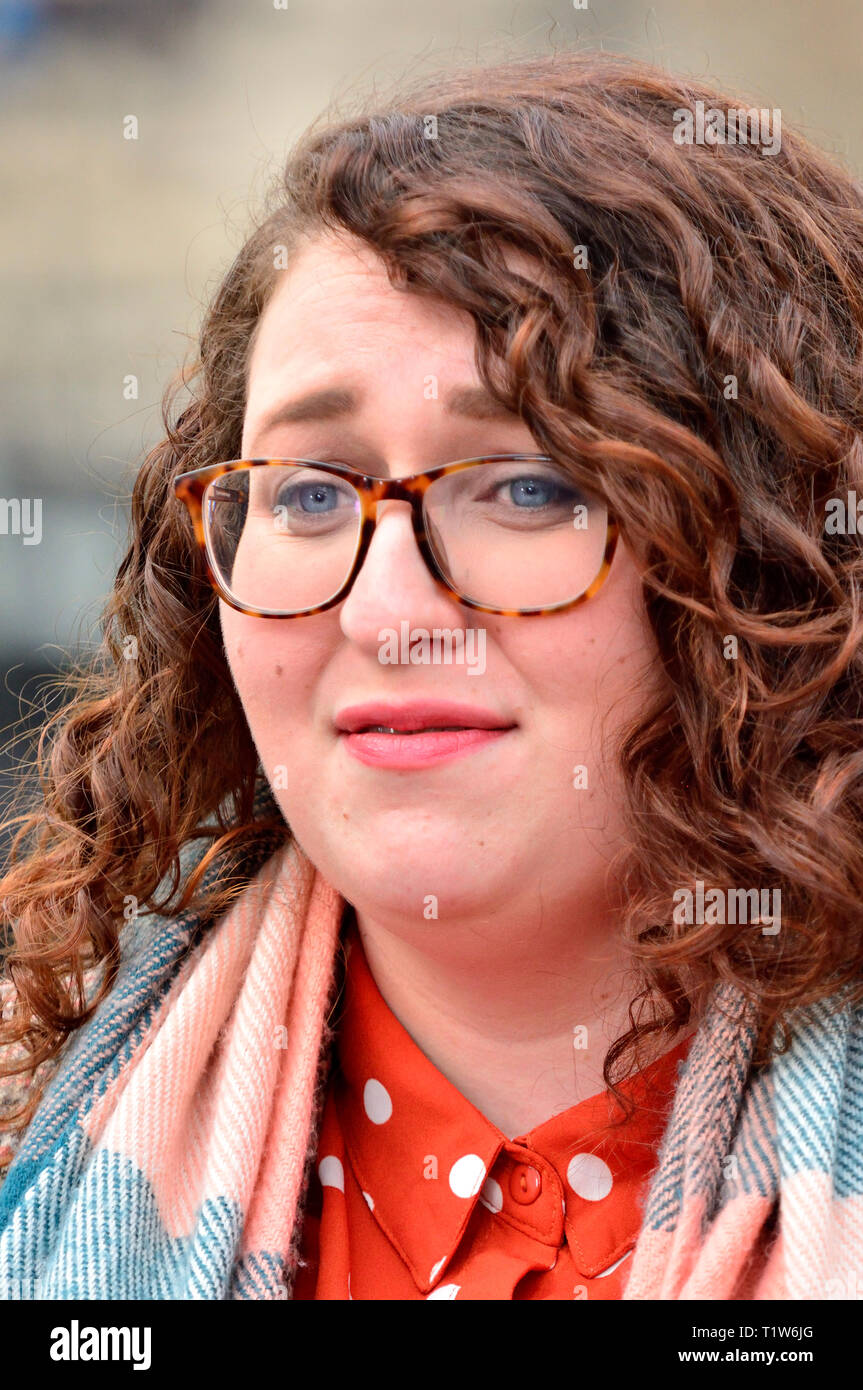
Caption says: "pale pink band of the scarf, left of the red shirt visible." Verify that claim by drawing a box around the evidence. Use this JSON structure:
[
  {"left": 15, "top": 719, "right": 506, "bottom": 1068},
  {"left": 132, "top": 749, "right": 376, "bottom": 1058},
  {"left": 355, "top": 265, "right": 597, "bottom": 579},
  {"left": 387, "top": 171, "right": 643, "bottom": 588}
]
[{"left": 85, "top": 842, "right": 342, "bottom": 1250}]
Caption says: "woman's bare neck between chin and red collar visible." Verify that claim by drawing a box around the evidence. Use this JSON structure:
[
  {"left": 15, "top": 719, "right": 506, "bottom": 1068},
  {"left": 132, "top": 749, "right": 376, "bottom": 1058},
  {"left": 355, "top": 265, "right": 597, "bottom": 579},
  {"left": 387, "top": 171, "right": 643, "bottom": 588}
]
[{"left": 343, "top": 909, "right": 691, "bottom": 1138}]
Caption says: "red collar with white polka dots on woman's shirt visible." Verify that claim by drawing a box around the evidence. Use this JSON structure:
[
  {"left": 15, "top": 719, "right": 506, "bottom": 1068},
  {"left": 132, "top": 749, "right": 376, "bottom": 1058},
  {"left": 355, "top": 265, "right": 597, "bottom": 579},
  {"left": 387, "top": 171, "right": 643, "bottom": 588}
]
[{"left": 335, "top": 912, "right": 691, "bottom": 1293}]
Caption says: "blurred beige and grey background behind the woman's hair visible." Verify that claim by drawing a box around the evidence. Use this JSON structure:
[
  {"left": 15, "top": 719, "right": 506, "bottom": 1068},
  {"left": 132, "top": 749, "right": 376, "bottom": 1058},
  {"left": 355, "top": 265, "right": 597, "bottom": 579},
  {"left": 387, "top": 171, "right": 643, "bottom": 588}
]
[{"left": 0, "top": 0, "right": 863, "bottom": 860}]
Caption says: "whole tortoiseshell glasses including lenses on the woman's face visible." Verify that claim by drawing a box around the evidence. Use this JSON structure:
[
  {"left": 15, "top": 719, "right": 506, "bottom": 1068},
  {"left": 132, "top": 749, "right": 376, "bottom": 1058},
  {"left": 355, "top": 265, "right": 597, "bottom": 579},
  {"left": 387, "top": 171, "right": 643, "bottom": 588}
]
[{"left": 174, "top": 453, "right": 618, "bottom": 617}]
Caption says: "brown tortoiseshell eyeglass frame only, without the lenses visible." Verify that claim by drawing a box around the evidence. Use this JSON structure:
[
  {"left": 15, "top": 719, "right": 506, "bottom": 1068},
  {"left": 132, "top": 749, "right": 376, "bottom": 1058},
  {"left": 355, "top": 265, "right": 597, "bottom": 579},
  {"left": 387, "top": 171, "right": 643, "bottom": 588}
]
[{"left": 174, "top": 453, "right": 620, "bottom": 619}]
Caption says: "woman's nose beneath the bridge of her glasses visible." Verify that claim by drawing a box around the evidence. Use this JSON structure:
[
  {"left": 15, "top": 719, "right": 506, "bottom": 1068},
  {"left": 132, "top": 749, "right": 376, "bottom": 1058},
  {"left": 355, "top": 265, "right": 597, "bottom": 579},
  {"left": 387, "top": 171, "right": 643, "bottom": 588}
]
[{"left": 340, "top": 500, "right": 466, "bottom": 653}]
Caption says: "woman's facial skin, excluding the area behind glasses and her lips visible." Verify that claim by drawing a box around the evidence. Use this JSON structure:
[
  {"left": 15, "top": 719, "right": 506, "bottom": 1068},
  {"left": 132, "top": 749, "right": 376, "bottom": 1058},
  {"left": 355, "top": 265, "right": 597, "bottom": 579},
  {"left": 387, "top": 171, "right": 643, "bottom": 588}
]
[{"left": 221, "top": 234, "right": 657, "bottom": 922}]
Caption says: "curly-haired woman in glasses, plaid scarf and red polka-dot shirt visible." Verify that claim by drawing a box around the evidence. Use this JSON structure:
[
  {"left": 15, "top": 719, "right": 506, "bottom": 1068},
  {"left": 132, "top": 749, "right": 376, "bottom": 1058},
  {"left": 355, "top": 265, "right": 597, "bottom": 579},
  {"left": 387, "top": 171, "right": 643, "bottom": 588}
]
[{"left": 0, "top": 54, "right": 863, "bottom": 1300}]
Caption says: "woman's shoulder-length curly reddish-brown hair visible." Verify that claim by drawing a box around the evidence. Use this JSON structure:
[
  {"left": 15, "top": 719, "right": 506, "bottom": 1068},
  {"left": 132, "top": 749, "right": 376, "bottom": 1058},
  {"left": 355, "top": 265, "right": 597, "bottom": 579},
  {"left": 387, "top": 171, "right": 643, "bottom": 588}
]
[{"left": 0, "top": 53, "right": 863, "bottom": 1126}]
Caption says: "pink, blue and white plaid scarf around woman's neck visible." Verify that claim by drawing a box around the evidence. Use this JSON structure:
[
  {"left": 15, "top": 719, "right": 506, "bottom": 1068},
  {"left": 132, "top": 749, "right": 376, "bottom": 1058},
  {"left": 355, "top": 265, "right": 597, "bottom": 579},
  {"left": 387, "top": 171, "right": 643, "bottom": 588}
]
[{"left": 0, "top": 792, "right": 863, "bottom": 1300}]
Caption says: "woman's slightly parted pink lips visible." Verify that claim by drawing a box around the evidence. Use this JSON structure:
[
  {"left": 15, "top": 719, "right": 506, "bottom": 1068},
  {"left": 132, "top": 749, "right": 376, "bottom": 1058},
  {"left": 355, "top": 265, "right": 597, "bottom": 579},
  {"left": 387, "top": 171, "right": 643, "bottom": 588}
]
[{"left": 335, "top": 701, "right": 516, "bottom": 771}]
